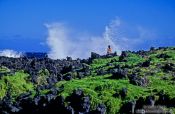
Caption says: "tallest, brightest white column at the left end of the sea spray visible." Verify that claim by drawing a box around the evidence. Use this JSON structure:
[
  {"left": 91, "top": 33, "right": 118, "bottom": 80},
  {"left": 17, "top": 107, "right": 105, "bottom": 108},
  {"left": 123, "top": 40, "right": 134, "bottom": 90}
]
[{"left": 46, "top": 23, "right": 69, "bottom": 59}]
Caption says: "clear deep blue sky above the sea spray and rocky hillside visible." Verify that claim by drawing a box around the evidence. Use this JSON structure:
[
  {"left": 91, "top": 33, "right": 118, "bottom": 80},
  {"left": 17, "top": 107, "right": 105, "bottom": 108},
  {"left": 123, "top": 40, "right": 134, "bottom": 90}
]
[{"left": 0, "top": 0, "right": 175, "bottom": 52}]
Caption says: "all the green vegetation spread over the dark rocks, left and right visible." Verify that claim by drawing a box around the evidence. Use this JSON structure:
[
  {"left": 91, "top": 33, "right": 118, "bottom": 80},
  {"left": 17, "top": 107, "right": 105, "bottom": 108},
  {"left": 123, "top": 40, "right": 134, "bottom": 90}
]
[{"left": 0, "top": 47, "right": 175, "bottom": 114}]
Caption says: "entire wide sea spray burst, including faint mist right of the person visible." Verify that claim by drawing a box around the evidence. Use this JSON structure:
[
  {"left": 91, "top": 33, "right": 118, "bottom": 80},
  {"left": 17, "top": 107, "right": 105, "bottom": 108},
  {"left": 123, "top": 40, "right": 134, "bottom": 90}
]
[{"left": 46, "top": 17, "right": 156, "bottom": 59}]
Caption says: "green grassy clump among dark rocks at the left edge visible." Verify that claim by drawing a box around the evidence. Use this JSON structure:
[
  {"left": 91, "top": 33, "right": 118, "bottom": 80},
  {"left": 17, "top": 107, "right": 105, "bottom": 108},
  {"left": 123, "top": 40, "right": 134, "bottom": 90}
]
[{"left": 0, "top": 71, "right": 34, "bottom": 99}]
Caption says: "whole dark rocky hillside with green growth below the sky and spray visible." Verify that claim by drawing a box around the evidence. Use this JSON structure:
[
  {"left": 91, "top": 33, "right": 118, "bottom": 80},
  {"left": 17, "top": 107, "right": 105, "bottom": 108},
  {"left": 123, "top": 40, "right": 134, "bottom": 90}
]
[{"left": 0, "top": 47, "right": 175, "bottom": 114}]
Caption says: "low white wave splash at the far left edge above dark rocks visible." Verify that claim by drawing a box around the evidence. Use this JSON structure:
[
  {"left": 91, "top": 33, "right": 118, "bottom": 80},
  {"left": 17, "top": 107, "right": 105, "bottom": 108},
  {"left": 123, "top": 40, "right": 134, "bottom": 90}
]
[{"left": 0, "top": 49, "right": 22, "bottom": 58}]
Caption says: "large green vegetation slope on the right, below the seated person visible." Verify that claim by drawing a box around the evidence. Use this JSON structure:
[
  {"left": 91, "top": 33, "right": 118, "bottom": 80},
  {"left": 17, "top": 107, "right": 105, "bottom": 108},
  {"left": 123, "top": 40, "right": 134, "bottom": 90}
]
[{"left": 56, "top": 48, "right": 175, "bottom": 114}]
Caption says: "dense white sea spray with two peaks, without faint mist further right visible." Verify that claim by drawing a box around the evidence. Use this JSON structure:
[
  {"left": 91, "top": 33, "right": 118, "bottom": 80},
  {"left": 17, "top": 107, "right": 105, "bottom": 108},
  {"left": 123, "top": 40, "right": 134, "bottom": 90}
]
[{"left": 45, "top": 19, "right": 120, "bottom": 59}]
